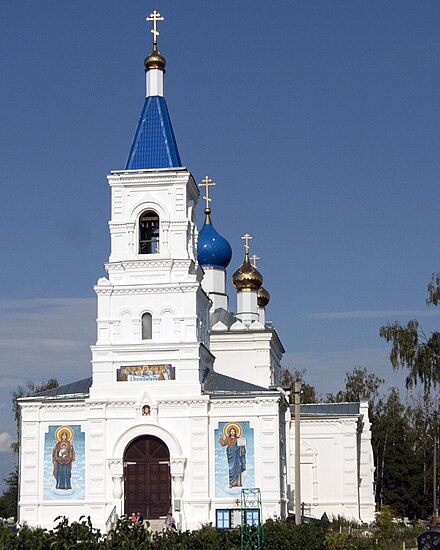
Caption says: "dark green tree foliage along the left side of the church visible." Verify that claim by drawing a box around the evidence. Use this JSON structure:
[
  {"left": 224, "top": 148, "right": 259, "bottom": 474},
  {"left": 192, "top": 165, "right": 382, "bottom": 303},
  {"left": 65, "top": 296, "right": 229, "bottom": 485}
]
[{"left": 0, "top": 378, "right": 58, "bottom": 517}]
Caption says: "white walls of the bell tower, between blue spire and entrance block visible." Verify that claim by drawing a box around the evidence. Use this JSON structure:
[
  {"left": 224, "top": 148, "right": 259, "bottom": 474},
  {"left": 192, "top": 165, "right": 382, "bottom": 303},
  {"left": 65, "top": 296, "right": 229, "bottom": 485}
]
[{"left": 90, "top": 169, "right": 214, "bottom": 398}]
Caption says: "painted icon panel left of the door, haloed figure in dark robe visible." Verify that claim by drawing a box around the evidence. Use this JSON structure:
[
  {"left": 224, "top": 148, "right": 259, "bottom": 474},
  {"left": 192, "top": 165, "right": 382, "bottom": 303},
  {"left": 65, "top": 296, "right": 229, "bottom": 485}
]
[{"left": 43, "top": 425, "right": 85, "bottom": 500}]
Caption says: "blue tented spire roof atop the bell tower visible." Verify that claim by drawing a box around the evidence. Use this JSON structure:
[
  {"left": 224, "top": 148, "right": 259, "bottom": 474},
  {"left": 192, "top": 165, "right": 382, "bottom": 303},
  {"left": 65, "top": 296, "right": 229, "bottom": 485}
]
[{"left": 125, "top": 96, "right": 182, "bottom": 170}]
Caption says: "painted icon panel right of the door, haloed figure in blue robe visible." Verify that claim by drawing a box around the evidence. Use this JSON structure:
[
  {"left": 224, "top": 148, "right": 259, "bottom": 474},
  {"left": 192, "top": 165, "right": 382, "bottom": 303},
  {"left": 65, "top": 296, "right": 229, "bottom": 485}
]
[{"left": 215, "top": 421, "right": 255, "bottom": 496}]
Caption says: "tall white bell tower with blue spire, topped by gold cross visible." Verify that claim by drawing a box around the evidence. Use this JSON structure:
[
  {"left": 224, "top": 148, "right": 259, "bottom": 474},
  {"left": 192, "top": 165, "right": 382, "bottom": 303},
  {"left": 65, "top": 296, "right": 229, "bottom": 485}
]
[{"left": 90, "top": 11, "right": 214, "bottom": 399}]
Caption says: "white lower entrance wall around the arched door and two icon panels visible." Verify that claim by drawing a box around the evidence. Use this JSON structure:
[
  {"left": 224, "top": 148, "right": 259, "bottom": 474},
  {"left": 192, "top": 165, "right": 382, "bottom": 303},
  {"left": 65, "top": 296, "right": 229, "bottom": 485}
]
[{"left": 19, "top": 392, "right": 286, "bottom": 529}]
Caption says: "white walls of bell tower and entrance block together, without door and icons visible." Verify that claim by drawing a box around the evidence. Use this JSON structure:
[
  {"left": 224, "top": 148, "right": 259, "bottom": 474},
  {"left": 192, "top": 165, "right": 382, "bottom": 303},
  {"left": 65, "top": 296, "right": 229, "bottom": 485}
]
[{"left": 20, "top": 165, "right": 287, "bottom": 529}]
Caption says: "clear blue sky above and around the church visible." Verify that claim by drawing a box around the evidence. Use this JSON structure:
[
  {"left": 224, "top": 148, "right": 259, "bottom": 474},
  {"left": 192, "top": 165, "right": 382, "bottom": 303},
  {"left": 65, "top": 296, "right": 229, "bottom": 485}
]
[{"left": 0, "top": 0, "right": 440, "bottom": 488}]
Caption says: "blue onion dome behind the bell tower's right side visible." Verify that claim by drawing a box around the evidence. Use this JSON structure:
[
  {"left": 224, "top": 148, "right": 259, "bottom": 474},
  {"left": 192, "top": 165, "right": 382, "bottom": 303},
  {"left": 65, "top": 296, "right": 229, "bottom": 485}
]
[{"left": 197, "top": 208, "right": 232, "bottom": 269}]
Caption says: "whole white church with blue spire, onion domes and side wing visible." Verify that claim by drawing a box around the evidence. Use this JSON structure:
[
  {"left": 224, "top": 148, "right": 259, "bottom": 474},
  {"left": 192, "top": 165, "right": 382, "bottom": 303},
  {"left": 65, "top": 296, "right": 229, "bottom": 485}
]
[{"left": 19, "top": 12, "right": 374, "bottom": 529}]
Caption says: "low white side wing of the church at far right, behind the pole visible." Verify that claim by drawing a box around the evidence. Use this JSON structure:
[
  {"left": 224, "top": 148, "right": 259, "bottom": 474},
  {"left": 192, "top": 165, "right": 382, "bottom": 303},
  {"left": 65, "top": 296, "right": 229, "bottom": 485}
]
[{"left": 289, "top": 403, "right": 375, "bottom": 523}]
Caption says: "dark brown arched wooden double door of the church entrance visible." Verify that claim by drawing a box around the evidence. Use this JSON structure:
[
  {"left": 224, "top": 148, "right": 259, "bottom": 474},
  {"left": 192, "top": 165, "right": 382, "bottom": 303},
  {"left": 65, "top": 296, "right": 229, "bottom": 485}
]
[{"left": 124, "top": 435, "right": 171, "bottom": 519}]
